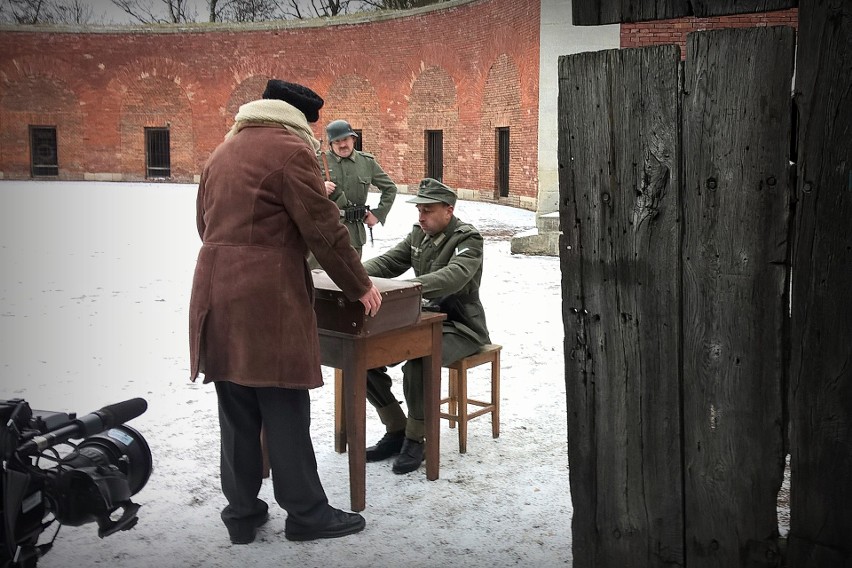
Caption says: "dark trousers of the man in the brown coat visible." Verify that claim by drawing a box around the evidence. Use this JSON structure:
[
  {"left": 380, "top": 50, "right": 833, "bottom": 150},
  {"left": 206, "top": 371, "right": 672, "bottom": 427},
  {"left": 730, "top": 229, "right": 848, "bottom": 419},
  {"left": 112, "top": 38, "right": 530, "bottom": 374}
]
[{"left": 215, "top": 381, "right": 331, "bottom": 527}]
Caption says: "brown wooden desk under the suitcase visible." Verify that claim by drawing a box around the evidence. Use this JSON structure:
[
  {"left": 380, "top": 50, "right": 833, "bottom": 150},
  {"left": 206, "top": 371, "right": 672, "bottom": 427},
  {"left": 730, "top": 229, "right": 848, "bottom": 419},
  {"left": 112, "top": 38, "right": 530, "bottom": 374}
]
[{"left": 319, "top": 312, "right": 446, "bottom": 511}]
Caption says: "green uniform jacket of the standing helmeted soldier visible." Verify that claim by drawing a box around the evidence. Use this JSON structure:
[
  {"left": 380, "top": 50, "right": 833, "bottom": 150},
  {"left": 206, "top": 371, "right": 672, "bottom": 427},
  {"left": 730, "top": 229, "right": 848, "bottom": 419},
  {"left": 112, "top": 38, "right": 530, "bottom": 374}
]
[{"left": 317, "top": 150, "right": 397, "bottom": 249}]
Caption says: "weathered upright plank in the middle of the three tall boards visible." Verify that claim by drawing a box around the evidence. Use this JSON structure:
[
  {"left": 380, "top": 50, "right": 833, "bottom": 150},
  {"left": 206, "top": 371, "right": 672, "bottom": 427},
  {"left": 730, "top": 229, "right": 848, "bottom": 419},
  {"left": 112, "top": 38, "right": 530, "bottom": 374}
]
[{"left": 683, "top": 27, "right": 794, "bottom": 568}]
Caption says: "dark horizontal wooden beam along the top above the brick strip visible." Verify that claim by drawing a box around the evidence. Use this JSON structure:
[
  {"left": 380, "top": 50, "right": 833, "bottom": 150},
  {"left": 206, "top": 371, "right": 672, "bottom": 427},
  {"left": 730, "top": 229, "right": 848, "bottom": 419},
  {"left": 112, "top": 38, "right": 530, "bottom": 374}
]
[{"left": 571, "top": 0, "right": 798, "bottom": 26}]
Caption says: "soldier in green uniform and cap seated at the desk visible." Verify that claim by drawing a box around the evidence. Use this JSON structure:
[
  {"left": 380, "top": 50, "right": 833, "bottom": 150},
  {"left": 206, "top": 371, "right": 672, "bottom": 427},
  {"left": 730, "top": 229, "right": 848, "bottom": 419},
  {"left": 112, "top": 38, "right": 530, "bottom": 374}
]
[{"left": 364, "top": 178, "right": 491, "bottom": 473}]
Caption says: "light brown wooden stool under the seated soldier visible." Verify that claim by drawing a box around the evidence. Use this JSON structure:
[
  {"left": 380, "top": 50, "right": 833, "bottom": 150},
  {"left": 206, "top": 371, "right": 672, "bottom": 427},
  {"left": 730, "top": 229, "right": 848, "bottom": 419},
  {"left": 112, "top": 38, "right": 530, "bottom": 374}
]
[{"left": 441, "top": 344, "right": 503, "bottom": 454}]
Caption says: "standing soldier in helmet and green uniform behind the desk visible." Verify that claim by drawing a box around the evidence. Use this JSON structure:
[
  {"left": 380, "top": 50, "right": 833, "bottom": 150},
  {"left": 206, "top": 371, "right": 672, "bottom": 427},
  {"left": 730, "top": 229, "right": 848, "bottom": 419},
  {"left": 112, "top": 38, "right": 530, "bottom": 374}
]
[{"left": 319, "top": 120, "right": 396, "bottom": 256}]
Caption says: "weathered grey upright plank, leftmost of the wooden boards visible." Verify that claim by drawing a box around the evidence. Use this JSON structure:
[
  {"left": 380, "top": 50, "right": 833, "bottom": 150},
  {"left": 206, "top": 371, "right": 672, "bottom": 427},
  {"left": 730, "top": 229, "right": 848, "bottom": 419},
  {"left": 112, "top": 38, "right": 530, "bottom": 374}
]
[{"left": 559, "top": 46, "right": 683, "bottom": 568}]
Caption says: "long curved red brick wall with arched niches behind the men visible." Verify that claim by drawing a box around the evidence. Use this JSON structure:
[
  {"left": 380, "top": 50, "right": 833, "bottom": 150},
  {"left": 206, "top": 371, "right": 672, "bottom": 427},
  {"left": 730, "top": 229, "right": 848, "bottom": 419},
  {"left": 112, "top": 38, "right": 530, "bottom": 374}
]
[{"left": 0, "top": 0, "right": 540, "bottom": 205}]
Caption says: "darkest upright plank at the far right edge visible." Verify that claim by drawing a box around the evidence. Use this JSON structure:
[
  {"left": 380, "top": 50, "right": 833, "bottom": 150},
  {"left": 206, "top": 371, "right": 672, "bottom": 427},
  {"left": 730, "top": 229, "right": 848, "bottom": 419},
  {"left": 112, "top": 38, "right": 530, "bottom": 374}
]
[{"left": 788, "top": 1, "right": 852, "bottom": 568}]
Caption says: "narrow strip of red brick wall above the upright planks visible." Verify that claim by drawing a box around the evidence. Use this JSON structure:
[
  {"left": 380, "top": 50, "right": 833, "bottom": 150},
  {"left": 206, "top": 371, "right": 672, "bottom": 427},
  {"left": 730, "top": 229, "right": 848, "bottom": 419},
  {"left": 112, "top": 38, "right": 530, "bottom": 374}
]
[{"left": 621, "top": 8, "right": 799, "bottom": 57}]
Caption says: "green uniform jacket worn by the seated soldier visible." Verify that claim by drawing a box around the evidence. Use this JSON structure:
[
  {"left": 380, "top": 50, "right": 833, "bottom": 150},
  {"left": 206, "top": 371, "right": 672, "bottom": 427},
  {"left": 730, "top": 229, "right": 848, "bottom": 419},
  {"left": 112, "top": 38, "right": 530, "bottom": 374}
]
[{"left": 364, "top": 216, "right": 491, "bottom": 345}]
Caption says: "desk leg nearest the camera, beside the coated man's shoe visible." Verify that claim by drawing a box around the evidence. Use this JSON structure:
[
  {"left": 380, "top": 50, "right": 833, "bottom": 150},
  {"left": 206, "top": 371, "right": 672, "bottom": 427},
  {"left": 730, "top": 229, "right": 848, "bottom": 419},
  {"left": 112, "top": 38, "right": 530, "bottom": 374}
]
[{"left": 343, "top": 356, "right": 367, "bottom": 511}]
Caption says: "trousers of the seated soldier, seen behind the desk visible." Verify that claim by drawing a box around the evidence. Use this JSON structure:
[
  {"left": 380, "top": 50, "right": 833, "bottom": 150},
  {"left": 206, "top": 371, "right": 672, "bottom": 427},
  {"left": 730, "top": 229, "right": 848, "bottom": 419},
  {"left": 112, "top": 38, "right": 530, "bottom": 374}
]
[{"left": 367, "top": 331, "right": 480, "bottom": 422}]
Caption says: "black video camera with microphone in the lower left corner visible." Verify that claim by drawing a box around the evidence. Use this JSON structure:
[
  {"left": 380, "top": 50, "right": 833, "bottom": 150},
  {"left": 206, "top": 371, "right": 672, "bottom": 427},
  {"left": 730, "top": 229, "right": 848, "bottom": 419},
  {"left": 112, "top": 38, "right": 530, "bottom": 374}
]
[{"left": 0, "top": 398, "right": 153, "bottom": 568}]
